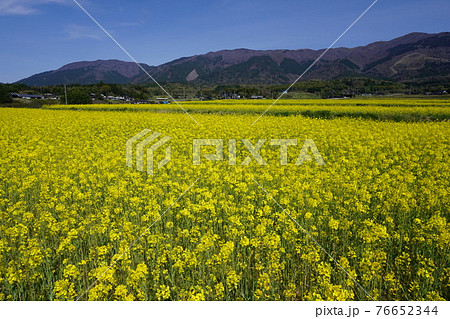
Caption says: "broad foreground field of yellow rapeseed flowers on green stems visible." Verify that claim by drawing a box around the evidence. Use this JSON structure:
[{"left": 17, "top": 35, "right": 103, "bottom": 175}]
[{"left": 0, "top": 101, "right": 450, "bottom": 300}]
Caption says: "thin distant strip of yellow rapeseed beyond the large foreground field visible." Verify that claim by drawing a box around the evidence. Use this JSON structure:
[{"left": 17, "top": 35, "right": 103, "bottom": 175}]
[{"left": 47, "top": 99, "right": 450, "bottom": 121}]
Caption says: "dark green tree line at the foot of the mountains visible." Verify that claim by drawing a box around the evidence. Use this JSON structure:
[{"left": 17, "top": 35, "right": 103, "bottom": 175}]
[{"left": 0, "top": 78, "right": 450, "bottom": 104}]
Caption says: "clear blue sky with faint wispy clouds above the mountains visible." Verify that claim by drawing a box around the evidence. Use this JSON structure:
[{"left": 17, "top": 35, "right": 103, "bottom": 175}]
[{"left": 0, "top": 0, "right": 450, "bottom": 82}]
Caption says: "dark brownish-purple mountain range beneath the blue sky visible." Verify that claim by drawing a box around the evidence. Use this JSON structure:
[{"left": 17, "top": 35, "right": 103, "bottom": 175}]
[{"left": 18, "top": 32, "right": 450, "bottom": 86}]
